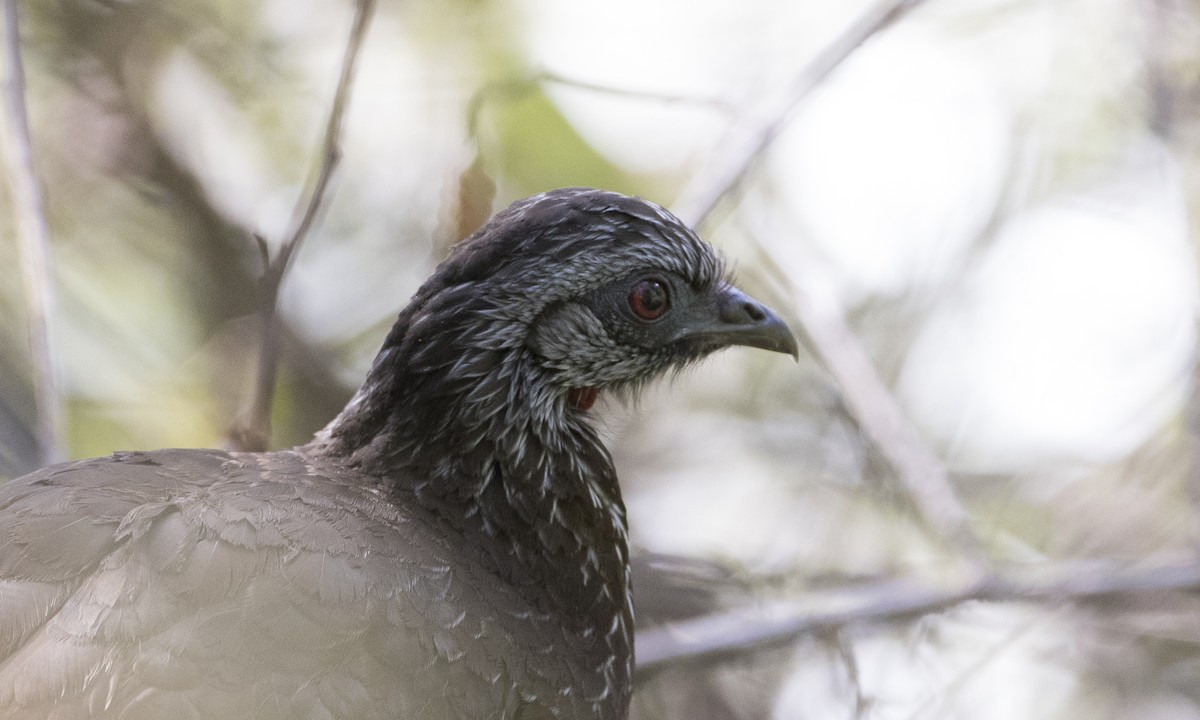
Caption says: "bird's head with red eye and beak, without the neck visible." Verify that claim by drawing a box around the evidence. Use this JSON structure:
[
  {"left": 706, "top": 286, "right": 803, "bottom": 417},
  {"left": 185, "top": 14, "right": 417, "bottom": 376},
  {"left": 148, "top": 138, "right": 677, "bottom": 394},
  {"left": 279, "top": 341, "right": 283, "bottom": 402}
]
[{"left": 437, "top": 188, "right": 797, "bottom": 409}]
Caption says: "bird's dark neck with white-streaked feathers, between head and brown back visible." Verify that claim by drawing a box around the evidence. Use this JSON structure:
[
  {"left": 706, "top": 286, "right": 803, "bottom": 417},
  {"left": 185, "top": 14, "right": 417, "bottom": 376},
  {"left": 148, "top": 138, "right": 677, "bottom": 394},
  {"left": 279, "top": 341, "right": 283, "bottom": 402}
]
[{"left": 308, "top": 321, "right": 630, "bottom": 629}]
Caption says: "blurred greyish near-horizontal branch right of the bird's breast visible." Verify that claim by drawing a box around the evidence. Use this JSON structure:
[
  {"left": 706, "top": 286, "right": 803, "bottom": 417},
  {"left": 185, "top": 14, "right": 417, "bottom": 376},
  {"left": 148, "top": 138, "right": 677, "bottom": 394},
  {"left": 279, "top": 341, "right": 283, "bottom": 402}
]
[{"left": 637, "top": 560, "right": 1200, "bottom": 680}]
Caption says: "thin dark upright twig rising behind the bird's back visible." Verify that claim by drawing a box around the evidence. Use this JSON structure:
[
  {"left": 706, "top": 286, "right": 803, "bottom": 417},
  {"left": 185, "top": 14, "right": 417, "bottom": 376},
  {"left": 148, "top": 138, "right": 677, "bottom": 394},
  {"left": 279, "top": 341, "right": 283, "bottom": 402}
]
[{"left": 229, "top": 0, "right": 376, "bottom": 451}]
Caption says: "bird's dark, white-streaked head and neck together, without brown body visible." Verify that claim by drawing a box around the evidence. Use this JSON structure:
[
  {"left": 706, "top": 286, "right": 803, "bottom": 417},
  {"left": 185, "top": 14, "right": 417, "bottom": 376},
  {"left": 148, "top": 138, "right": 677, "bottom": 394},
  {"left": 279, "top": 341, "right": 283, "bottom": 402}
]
[{"left": 307, "top": 190, "right": 797, "bottom": 691}]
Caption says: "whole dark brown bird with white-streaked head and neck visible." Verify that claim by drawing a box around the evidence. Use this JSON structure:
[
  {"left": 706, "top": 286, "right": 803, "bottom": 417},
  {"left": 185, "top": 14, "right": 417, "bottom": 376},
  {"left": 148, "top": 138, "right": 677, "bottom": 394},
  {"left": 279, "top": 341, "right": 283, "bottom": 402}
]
[{"left": 0, "top": 190, "right": 797, "bottom": 720}]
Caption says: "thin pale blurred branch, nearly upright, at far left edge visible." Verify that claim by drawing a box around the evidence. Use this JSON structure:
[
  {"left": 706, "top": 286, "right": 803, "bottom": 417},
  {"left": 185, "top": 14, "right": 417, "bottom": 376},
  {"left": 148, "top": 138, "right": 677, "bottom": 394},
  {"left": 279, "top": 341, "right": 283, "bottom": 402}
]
[{"left": 4, "top": 0, "right": 65, "bottom": 464}]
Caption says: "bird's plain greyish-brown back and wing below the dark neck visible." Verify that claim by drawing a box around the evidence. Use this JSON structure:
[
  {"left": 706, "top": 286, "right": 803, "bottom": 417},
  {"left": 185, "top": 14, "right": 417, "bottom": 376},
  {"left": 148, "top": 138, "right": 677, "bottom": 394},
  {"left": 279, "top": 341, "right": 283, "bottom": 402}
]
[{"left": 0, "top": 450, "right": 606, "bottom": 720}]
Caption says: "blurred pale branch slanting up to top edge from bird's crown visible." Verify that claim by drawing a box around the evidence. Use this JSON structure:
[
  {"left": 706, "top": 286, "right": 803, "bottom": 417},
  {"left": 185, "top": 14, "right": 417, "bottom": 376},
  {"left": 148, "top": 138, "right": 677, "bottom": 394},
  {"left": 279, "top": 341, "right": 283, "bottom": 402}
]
[{"left": 673, "top": 0, "right": 924, "bottom": 227}]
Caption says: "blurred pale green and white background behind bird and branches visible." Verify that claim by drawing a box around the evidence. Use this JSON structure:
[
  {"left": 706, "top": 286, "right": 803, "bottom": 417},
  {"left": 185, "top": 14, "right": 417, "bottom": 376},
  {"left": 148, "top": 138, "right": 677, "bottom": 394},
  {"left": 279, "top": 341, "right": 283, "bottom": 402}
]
[{"left": 0, "top": 0, "right": 1200, "bottom": 720}]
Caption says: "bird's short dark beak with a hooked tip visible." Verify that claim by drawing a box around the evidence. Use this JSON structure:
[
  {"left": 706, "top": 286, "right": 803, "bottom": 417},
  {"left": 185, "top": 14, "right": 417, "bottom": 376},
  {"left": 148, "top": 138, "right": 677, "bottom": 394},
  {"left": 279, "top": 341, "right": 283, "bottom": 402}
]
[{"left": 672, "top": 286, "right": 800, "bottom": 360}]
